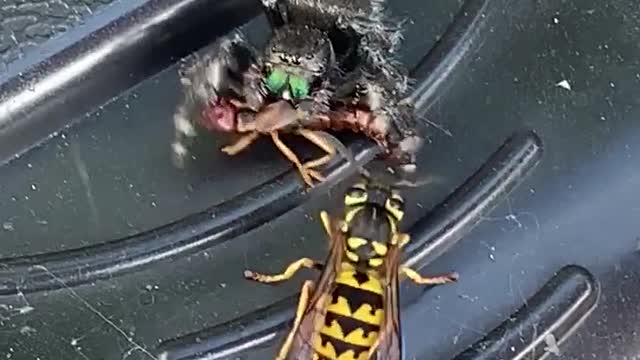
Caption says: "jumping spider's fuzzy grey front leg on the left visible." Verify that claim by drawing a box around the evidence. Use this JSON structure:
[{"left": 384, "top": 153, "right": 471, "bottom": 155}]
[{"left": 171, "top": 33, "right": 258, "bottom": 168}]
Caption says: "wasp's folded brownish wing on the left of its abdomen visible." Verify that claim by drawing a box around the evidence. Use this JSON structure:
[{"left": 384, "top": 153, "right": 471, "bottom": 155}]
[{"left": 286, "top": 212, "right": 345, "bottom": 360}]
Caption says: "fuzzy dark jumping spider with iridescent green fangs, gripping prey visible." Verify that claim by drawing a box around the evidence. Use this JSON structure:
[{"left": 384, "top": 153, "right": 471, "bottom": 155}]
[{"left": 172, "top": 0, "right": 422, "bottom": 185}]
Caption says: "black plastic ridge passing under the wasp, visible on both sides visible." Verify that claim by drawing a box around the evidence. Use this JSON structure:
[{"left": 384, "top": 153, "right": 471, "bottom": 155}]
[{"left": 154, "top": 128, "right": 542, "bottom": 360}]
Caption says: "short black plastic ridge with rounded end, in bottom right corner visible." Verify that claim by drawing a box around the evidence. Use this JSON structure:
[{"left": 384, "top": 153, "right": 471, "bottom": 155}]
[{"left": 454, "top": 265, "right": 600, "bottom": 360}]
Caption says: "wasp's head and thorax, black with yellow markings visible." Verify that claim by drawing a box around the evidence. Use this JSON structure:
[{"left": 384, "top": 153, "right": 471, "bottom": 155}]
[{"left": 343, "top": 181, "right": 404, "bottom": 267}]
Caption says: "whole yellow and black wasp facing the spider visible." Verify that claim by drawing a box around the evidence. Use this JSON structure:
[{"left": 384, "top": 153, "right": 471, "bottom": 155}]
[{"left": 244, "top": 179, "right": 458, "bottom": 360}]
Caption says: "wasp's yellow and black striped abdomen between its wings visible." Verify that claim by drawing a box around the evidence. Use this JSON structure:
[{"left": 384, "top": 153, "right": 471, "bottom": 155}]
[{"left": 314, "top": 263, "right": 384, "bottom": 360}]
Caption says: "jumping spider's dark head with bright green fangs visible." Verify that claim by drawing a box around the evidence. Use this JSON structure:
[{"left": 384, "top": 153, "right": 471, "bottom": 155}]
[{"left": 265, "top": 26, "right": 335, "bottom": 100}]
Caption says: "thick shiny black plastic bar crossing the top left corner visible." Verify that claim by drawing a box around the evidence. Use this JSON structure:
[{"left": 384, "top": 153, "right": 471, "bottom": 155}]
[{"left": 0, "top": 0, "right": 260, "bottom": 164}]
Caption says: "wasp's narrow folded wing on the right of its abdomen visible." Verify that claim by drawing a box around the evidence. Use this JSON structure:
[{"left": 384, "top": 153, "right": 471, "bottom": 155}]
[{"left": 369, "top": 247, "right": 402, "bottom": 360}]
